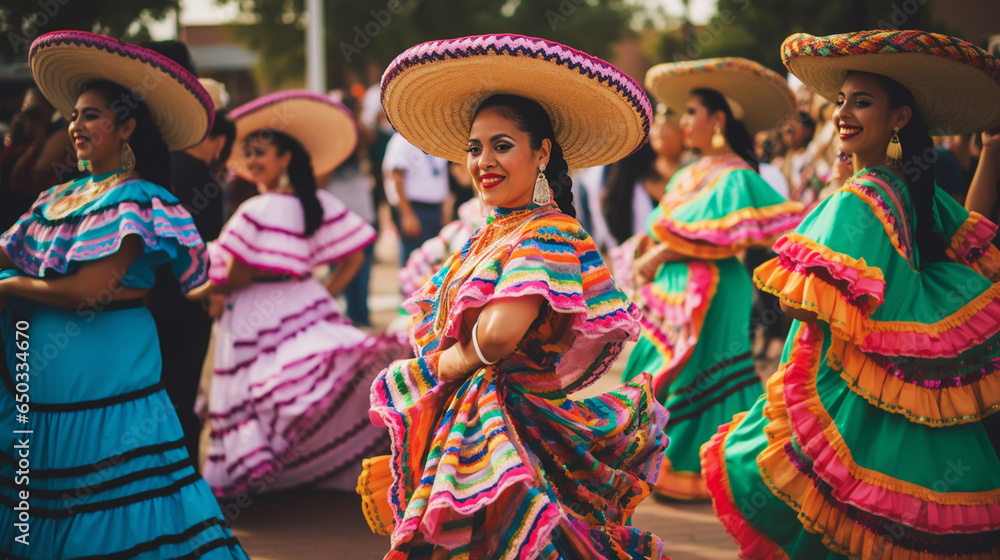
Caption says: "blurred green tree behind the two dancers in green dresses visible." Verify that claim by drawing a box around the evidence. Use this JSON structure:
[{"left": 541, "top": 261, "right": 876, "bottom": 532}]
[{"left": 649, "top": 0, "right": 949, "bottom": 74}]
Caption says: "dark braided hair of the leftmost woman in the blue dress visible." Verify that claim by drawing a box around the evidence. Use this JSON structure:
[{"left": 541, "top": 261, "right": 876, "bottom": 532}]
[{"left": 83, "top": 80, "right": 172, "bottom": 189}]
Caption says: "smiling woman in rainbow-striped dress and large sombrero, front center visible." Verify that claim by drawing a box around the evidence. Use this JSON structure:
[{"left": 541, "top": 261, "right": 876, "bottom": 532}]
[{"left": 359, "top": 35, "right": 666, "bottom": 560}]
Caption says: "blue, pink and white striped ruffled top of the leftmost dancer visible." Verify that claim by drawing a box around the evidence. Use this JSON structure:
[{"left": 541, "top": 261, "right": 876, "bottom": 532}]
[{"left": 0, "top": 179, "right": 207, "bottom": 292}]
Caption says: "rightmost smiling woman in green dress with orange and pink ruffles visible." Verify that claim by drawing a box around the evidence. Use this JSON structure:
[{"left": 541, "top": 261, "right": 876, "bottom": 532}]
[{"left": 702, "top": 31, "right": 1000, "bottom": 560}]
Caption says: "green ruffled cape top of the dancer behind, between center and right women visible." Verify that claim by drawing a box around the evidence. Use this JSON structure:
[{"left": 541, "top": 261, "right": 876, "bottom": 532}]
[{"left": 647, "top": 160, "right": 802, "bottom": 259}]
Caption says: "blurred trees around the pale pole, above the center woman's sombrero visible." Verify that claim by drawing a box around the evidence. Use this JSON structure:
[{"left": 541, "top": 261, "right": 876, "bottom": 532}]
[{"left": 225, "top": 0, "right": 641, "bottom": 88}]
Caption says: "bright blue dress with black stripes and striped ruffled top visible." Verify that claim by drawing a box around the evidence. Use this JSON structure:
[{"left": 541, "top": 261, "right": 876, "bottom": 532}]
[{"left": 0, "top": 174, "right": 246, "bottom": 560}]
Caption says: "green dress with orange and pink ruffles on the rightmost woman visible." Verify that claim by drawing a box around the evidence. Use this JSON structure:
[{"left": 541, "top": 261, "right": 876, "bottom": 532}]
[{"left": 702, "top": 168, "right": 1000, "bottom": 560}]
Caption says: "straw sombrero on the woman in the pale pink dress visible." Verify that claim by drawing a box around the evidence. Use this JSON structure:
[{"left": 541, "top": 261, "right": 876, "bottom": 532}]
[{"left": 229, "top": 90, "right": 358, "bottom": 175}]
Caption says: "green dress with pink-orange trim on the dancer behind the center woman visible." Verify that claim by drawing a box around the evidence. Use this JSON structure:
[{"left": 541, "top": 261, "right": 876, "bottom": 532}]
[{"left": 624, "top": 154, "right": 802, "bottom": 500}]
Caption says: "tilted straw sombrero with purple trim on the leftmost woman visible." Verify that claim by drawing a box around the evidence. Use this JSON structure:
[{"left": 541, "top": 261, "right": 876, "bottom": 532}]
[{"left": 28, "top": 31, "right": 215, "bottom": 150}]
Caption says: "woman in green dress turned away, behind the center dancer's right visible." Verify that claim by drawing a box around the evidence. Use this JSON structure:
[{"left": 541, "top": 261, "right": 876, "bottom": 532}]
[{"left": 623, "top": 58, "right": 802, "bottom": 500}]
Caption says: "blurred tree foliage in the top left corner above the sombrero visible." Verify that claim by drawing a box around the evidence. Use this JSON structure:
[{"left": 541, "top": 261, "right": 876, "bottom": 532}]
[{"left": 0, "top": 0, "right": 180, "bottom": 61}]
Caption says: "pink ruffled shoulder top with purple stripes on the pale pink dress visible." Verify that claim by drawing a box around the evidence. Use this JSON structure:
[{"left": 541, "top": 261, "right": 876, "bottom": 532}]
[{"left": 209, "top": 191, "right": 375, "bottom": 284}]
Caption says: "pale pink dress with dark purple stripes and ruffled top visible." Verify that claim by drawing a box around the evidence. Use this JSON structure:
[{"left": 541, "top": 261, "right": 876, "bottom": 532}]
[{"left": 205, "top": 191, "right": 413, "bottom": 497}]
